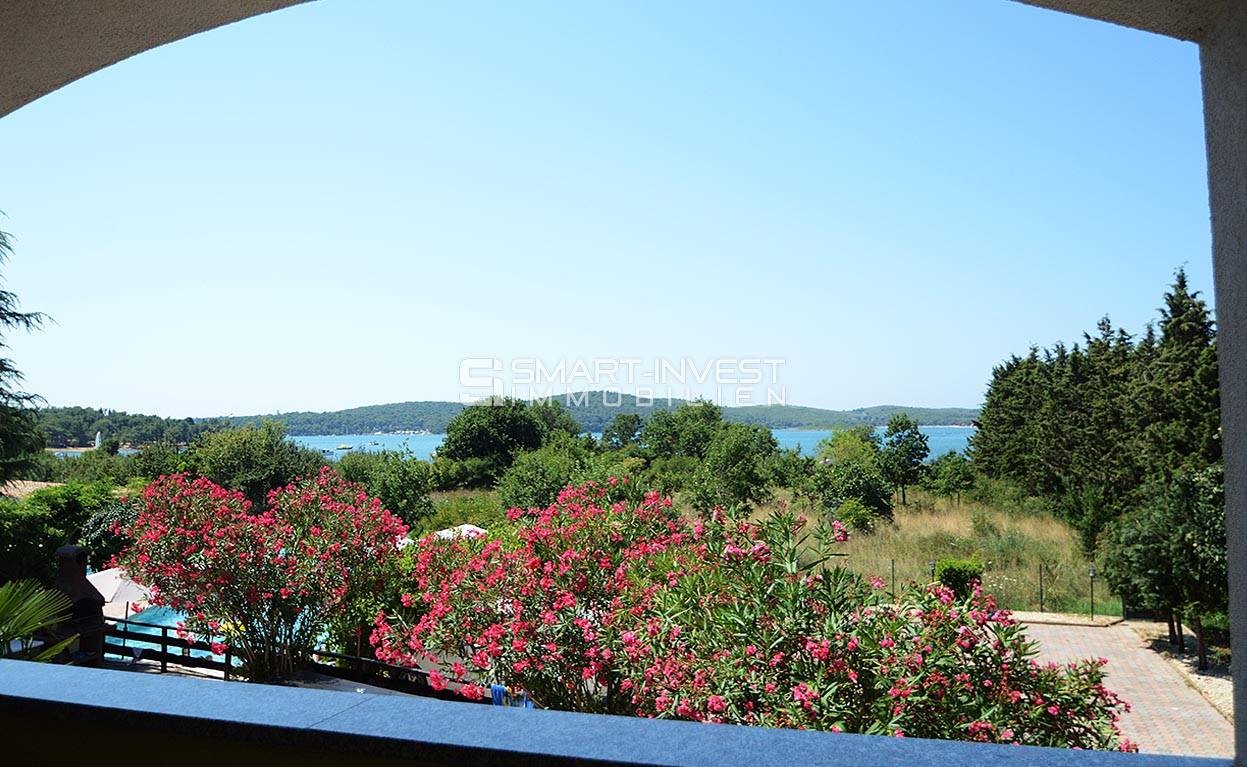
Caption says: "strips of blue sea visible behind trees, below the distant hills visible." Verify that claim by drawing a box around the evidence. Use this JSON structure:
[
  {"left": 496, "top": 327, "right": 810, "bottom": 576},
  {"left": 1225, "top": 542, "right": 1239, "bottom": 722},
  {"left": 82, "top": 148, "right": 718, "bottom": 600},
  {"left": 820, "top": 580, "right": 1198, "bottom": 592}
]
[{"left": 229, "top": 392, "right": 979, "bottom": 435}]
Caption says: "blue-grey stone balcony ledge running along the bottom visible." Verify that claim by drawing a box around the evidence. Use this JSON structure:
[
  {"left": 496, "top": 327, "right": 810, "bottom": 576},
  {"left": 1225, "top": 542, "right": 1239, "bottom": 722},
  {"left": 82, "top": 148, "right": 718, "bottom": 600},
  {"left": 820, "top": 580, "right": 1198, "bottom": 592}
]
[{"left": 0, "top": 660, "right": 1230, "bottom": 767}]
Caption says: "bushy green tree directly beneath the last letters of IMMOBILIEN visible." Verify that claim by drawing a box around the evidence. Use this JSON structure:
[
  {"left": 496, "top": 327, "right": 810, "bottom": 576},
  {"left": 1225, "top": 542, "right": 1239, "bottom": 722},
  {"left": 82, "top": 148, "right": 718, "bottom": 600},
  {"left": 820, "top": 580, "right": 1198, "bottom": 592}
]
[{"left": 690, "top": 424, "right": 779, "bottom": 510}]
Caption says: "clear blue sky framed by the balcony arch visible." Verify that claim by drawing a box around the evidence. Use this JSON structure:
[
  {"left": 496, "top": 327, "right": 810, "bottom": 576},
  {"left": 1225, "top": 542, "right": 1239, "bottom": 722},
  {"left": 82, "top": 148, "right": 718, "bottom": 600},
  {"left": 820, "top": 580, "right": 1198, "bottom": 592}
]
[{"left": 0, "top": 0, "right": 1212, "bottom": 417}]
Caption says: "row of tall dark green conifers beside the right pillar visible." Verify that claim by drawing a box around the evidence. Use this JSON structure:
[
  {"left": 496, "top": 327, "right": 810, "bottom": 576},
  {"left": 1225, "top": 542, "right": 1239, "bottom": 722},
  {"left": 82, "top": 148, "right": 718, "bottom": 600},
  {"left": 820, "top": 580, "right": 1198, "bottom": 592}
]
[{"left": 970, "top": 271, "right": 1221, "bottom": 551}]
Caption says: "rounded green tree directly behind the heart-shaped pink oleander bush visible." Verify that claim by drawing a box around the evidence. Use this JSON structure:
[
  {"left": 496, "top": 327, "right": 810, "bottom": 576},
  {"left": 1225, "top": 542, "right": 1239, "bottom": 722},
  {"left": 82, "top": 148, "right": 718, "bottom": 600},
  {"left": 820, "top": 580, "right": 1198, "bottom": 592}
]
[{"left": 185, "top": 420, "right": 325, "bottom": 506}]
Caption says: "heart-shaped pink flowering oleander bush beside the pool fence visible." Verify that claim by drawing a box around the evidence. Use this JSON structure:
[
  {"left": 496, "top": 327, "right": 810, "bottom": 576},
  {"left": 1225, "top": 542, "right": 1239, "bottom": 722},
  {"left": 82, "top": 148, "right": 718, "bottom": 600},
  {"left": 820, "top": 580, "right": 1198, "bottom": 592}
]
[{"left": 117, "top": 468, "right": 407, "bottom": 678}]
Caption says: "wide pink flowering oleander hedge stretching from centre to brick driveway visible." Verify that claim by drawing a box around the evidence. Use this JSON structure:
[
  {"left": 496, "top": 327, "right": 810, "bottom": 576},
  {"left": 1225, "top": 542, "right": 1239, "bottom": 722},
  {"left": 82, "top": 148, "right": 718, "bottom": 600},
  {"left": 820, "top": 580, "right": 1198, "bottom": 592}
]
[{"left": 373, "top": 484, "right": 1132, "bottom": 750}]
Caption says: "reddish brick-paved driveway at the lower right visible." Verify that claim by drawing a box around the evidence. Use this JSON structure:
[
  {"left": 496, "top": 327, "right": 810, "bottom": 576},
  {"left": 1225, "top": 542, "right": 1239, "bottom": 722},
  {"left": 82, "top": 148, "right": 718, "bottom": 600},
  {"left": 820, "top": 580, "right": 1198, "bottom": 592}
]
[{"left": 1026, "top": 624, "right": 1233, "bottom": 757}]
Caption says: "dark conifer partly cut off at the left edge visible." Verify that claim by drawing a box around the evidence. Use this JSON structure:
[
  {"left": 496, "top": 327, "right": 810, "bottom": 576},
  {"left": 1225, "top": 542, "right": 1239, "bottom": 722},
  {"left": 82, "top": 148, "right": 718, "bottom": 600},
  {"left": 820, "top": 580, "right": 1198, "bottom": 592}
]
[{"left": 0, "top": 223, "right": 46, "bottom": 484}]
